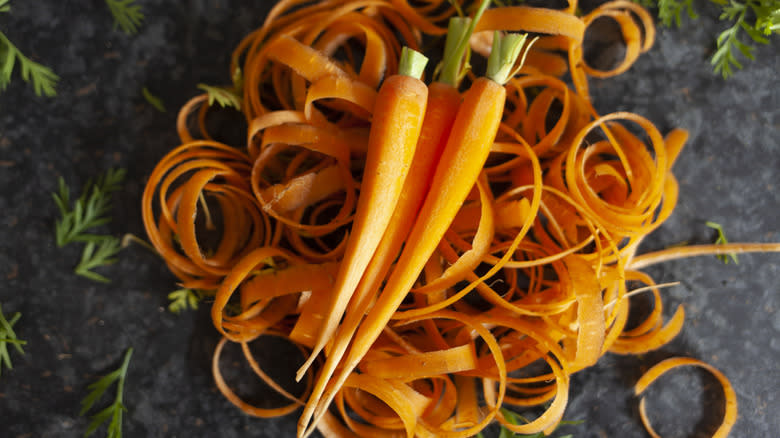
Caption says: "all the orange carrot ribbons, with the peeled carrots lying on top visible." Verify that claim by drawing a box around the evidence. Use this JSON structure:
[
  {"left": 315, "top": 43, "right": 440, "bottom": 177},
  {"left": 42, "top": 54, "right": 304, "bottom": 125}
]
[{"left": 143, "top": 0, "right": 780, "bottom": 438}]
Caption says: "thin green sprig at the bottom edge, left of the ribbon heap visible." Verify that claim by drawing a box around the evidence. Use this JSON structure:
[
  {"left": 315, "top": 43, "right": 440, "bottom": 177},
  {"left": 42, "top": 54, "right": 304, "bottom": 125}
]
[{"left": 79, "top": 348, "right": 133, "bottom": 438}]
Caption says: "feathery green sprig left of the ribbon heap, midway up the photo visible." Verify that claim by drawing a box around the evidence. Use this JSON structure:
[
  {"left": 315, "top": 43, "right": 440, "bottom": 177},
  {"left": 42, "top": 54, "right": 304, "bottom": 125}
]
[{"left": 52, "top": 169, "right": 126, "bottom": 283}]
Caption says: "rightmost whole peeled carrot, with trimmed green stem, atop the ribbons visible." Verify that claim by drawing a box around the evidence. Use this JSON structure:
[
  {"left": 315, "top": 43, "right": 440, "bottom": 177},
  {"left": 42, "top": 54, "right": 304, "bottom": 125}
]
[{"left": 298, "top": 30, "right": 525, "bottom": 436}]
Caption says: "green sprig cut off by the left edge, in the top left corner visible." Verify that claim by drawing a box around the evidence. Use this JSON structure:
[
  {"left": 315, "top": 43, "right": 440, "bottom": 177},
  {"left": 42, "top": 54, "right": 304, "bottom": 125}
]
[{"left": 0, "top": 0, "right": 60, "bottom": 97}]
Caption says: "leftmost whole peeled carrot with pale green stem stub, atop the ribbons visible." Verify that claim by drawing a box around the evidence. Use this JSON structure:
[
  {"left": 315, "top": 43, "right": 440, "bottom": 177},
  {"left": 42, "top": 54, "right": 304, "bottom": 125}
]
[{"left": 298, "top": 47, "right": 428, "bottom": 380}]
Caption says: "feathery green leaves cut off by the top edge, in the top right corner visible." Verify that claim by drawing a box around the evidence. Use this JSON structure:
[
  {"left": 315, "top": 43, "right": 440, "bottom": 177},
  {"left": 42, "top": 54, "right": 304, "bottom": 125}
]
[{"left": 634, "top": 0, "right": 780, "bottom": 78}]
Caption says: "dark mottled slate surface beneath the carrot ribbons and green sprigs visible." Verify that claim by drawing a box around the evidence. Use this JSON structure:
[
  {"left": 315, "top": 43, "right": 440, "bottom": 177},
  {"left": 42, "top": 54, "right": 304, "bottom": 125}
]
[{"left": 0, "top": 0, "right": 780, "bottom": 438}]
